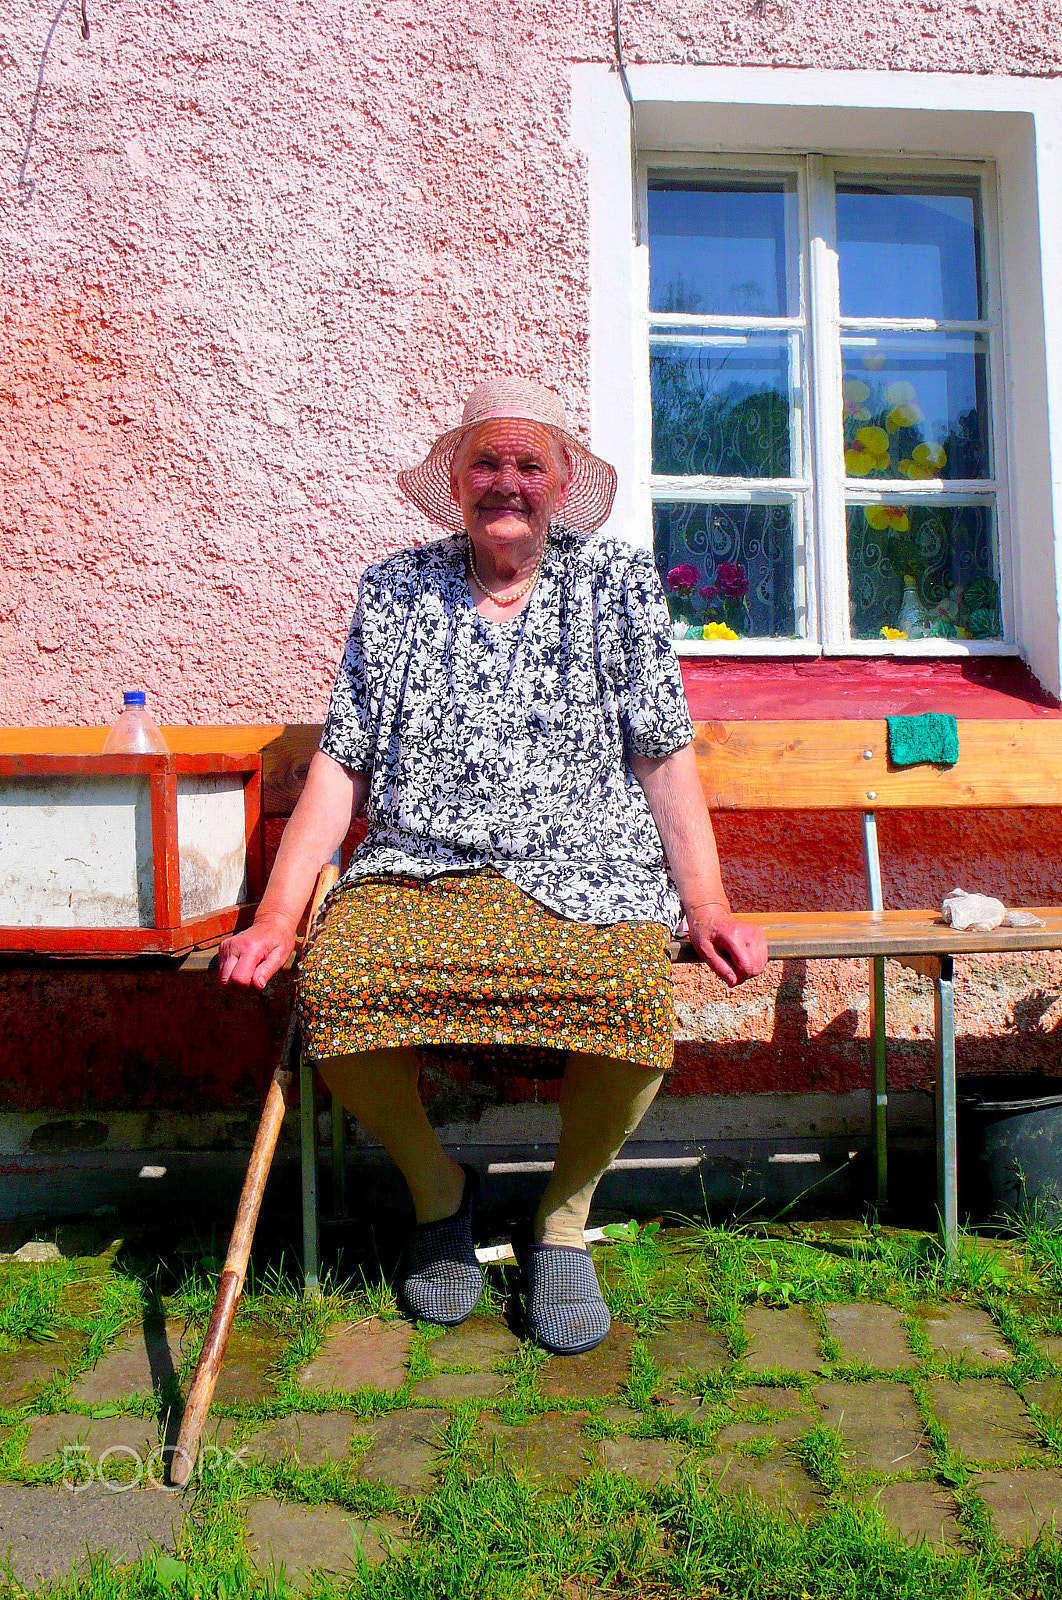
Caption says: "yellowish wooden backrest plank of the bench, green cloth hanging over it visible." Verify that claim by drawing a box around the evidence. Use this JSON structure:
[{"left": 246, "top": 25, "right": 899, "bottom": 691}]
[{"left": 0, "top": 717, "right": 1062, "bottom": 816}]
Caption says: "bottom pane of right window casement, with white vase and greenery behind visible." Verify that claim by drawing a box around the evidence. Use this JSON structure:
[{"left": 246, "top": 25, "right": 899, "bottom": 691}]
[{"left": 848, "top": 506, "right": 1003, "bottom": 638}]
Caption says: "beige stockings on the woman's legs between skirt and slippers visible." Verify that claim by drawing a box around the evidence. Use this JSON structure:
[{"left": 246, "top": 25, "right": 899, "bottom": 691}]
[{"left": 318, "top": 1050, "right": 662, "bottom": 1246}]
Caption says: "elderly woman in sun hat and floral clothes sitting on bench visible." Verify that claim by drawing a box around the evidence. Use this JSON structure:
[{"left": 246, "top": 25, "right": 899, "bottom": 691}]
[{"left": 221, "top": 378, "right": 766, "bottom": 1354}]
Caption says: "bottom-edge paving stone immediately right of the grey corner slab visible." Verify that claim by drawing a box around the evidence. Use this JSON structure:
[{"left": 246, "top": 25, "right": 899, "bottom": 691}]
[{"left": 245, "top": 1499, "right": 409, "bottom": 1590}]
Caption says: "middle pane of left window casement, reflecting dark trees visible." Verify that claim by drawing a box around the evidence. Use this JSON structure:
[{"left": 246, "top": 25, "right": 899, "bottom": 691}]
[{"left": 649, "top": 331, "right": 792, "bottom": 478}]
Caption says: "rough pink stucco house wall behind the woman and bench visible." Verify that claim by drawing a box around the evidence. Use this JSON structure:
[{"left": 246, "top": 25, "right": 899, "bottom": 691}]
[{"left": 0, "top": 0, "right": 1062, "bottom": 1126}]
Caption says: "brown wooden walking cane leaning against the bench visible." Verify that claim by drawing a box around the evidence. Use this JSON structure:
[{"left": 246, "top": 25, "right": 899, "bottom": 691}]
[{"left": 170, "top": 862, "right": 339, "bottom": 1488}]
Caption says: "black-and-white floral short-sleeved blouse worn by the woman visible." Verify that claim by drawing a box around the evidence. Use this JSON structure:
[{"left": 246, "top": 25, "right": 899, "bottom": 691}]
[{"left": 321, "top": 526, "right": 693, "bottom": 930}]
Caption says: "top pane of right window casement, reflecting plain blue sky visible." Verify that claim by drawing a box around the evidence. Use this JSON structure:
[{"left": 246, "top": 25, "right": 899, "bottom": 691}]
[{"left": 836, "top": 182, "right": 984, "bottom": 322}]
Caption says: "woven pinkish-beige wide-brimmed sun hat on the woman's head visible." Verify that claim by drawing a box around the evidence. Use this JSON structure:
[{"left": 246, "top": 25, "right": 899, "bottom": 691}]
[{"left": 398, "top": 378, "right": 616, "bottom": 533}]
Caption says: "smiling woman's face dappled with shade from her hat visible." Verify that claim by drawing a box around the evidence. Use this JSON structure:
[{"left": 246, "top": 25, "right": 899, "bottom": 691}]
[{"left": 449, "top": 418, "right": 568, "bottom": 550}]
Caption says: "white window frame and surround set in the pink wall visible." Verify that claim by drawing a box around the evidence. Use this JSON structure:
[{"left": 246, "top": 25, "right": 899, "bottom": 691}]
[{"left": 573, "top": 66, "right": 1062, "bottom": 696}]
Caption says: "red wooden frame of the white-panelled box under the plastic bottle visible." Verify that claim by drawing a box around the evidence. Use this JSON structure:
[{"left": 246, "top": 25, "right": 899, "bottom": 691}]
[{"left": 0, "top": 752, "right": 266, "bottom": 955}]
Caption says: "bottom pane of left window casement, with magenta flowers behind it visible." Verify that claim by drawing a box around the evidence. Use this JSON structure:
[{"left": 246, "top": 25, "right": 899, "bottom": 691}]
[{"left": 653, "top": 502, "right": 803, "bottom": 638}]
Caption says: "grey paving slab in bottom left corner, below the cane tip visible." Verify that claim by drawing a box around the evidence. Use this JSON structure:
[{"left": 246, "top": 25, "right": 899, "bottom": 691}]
[{"left": 0, "top": 1483, "right": 184, "bottom": 1584}]
